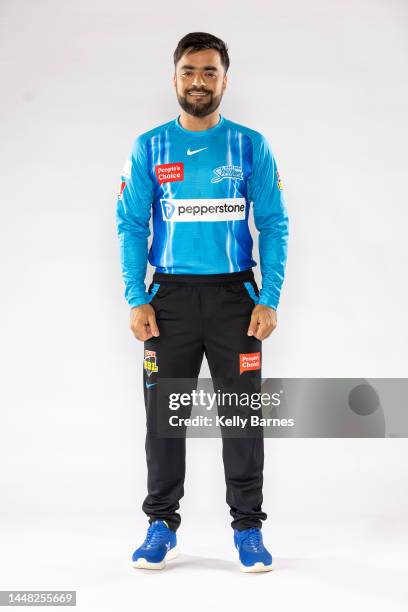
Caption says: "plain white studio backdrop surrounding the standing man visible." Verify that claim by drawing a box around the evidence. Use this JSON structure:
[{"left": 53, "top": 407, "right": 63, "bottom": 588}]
[{"left": 0, "top": 0, "right": 408, "bottom": 610}]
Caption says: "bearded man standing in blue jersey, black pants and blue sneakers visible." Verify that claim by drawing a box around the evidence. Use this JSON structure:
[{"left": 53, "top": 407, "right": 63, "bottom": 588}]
[{"left": 117, "top": 32, "right": 288, "bottom": 572}]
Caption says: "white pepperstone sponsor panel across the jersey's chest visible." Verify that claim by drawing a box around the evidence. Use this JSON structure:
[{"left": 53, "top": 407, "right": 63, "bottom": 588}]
[{"left": 160, "top": 198, "right": 245, "bottom": 222}]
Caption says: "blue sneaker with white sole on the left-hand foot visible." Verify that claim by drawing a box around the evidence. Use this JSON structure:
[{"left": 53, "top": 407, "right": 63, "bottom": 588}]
[{"left": 132, "top": 521, "right": 178, "bottom": 569}]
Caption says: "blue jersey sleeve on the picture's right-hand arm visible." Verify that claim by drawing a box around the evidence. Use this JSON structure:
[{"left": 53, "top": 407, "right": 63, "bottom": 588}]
[{"left": 249, "top": 135, "right": 289, "bottom": 310}]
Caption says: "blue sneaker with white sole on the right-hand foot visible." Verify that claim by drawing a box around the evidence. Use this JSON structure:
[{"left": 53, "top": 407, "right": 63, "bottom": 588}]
[{"left": 234, "top": 527, "right": 272, "bottom": 572}]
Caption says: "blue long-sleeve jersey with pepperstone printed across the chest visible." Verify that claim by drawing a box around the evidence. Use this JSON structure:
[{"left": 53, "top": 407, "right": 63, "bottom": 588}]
[{"left": 117, "top": 115, "right": 288, "bottom": 309}]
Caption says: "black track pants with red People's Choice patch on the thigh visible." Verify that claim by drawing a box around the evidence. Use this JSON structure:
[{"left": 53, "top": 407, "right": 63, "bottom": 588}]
[{"left": 142, "top": 270, "right": 266, "bottom": 531}]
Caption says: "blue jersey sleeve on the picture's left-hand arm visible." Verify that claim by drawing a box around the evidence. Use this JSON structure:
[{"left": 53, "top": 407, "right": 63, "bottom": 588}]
[{"left": 116, "top": 137, "right": 153, "bottom": 307}]
